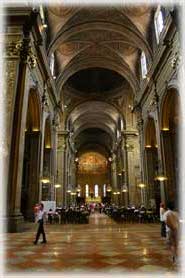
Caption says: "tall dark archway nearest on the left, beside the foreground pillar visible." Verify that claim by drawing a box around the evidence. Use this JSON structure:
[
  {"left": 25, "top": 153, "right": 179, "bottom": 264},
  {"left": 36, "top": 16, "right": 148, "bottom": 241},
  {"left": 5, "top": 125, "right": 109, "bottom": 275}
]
[{"left": 21, "top": 89, "right": 41, "bottom": 220}]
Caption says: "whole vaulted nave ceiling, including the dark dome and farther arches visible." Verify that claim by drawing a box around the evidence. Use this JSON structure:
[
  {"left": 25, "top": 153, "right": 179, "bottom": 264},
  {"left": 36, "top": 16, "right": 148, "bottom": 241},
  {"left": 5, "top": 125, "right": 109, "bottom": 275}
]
[{"left": 47, "top": 4, "right": 153, "bottom": 155}]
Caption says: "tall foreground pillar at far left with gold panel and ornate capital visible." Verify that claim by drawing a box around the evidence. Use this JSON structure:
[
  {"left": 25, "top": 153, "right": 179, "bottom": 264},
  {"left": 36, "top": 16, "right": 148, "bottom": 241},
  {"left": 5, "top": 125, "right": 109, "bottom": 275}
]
[{"left": 4, "top": 12, "right": 36, "bottom": 231}]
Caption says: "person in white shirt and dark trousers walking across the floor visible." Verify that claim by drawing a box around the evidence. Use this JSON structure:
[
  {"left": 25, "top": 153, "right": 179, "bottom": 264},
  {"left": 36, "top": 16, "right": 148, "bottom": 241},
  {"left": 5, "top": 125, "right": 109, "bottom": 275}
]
[{"left": 33, "top": 203, "right": 47, "bottom": 244}]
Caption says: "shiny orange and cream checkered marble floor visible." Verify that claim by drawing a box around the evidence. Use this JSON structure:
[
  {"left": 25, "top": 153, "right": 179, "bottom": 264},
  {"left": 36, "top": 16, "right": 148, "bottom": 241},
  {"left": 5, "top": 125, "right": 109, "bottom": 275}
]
[{"left": 3, "top": 213, "right": 179, "bottom": 277}]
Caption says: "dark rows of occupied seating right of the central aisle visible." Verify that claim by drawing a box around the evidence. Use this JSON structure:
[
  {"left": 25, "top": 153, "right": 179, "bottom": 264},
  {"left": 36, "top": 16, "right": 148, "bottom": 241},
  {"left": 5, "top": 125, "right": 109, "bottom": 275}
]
[{"left": 104, "top": 206, "right": 159, "bottom": 223}]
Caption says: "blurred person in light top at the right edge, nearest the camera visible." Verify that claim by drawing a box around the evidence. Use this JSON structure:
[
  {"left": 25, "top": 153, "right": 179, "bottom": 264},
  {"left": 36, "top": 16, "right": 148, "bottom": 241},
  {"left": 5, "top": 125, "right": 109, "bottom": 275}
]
[{"left": 163, "top": 202, "right": 179, "bottom": 263}]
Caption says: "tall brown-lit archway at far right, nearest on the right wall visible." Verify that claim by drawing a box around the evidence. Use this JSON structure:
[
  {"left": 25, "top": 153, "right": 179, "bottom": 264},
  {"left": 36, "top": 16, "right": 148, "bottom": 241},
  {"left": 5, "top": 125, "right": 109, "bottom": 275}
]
[{"left": 161, "top": 89, "right": 180, "bottom": 206}]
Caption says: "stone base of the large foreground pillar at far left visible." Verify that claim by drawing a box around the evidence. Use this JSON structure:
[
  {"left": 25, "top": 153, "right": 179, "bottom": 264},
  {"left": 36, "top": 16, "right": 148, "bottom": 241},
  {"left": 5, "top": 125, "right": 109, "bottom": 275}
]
[{"left": 5, "top": 214, "right": 24, "bottom": 233}]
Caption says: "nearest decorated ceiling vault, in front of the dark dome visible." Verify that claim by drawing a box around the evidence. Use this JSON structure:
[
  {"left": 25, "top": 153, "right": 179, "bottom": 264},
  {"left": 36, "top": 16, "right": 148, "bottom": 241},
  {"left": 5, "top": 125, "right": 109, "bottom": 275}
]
[{"left": 48, "top": 6, "right": 152, "bottom": 93}]
